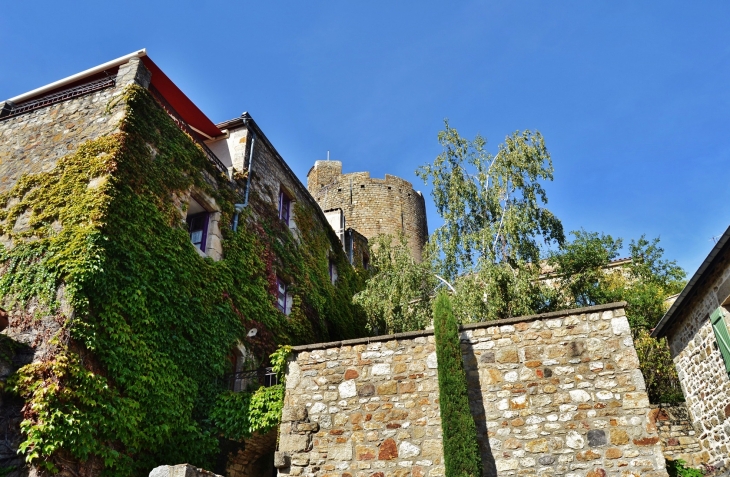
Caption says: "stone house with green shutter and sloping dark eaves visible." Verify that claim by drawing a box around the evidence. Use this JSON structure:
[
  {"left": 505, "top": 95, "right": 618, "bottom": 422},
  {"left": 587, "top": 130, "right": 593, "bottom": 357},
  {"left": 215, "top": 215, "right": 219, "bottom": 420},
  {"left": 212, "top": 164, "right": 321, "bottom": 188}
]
[{"left": 652, "top": 223, "right": 730, "bottom": 472}]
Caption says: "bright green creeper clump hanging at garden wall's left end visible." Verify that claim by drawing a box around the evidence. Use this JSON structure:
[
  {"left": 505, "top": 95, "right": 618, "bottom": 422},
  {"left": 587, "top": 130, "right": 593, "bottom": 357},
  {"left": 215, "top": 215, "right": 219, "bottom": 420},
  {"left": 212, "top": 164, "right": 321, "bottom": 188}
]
[{"left": 210, "top": 346, "right": 291, "bottom": 440}]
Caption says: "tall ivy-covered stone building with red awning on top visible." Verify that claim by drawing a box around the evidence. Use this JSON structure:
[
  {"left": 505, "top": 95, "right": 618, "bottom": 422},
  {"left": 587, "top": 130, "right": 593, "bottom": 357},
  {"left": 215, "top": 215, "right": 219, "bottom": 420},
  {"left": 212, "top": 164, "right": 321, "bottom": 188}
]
[{"left": 0, "top": 50, "right": 365, "bottom": 476}]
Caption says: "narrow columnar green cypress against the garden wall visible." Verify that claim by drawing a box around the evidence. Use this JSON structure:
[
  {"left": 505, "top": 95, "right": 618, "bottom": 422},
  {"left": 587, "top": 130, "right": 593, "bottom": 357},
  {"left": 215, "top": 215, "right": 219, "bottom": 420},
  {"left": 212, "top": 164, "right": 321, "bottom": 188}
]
[{"left": 433, "top": 292, "right": 482, "bottom": 477}]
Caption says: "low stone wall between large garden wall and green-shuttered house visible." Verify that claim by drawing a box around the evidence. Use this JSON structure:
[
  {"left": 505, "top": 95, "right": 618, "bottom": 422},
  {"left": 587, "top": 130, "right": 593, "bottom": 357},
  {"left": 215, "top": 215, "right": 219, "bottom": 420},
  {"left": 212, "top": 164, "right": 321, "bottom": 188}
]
[{"left": 649, "top": 403, "right": 704, "bottom": 466}]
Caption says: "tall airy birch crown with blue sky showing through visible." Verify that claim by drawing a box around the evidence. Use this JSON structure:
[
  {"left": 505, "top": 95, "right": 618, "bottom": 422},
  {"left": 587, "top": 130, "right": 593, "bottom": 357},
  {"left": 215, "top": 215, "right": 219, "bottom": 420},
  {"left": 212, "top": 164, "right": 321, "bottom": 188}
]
[{"left": 416, "top": 121, "right": 564, "bottom": 279}]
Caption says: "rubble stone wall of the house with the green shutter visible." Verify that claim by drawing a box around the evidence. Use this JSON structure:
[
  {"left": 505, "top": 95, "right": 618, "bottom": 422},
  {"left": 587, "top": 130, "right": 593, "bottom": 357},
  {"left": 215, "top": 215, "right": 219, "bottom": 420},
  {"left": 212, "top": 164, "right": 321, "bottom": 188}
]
[{"left": 666, "top": 247, "right": 730, "bottom": 470}]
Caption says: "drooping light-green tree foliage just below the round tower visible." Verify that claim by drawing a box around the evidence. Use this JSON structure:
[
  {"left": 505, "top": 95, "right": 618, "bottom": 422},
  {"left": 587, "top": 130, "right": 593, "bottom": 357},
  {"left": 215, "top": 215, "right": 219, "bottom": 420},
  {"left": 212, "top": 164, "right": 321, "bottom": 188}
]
[{"left": 353, "top": 235, "right": 437, "bottom": 334}]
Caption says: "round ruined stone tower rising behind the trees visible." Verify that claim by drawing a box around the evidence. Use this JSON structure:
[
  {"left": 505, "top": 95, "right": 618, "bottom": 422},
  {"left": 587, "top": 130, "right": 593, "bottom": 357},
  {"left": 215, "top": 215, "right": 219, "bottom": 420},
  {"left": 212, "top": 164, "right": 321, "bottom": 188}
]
[{"left": 307, "top": 161, "right": 428, "bottom": 262}]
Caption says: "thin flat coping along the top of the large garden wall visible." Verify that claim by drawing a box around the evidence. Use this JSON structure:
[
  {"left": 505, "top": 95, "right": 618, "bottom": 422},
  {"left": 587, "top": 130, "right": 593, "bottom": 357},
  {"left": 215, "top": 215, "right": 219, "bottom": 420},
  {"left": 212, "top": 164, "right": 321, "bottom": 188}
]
[{"left": 292, "top": 301, "right": 626, "bottom": 353}]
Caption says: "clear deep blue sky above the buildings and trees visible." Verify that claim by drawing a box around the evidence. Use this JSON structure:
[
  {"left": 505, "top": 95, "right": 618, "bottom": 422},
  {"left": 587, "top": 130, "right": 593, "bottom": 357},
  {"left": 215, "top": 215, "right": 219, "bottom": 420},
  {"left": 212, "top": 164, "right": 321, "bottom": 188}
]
[{"left": 0, "top": 0, "right": 730, "bottom": 274}]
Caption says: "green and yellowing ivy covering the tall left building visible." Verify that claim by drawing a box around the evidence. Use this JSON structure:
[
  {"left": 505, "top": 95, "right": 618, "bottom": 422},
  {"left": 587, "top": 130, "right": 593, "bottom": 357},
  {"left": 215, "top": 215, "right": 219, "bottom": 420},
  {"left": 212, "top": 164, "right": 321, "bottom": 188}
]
[{"left": 0, "top": 61, "right": 364, "bottom": 475}]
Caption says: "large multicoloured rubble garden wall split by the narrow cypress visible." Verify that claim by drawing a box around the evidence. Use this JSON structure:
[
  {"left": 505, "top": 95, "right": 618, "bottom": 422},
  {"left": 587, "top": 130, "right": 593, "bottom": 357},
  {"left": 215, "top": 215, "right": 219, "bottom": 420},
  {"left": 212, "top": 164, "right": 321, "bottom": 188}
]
[{"left": 279, "top": 304, "right": 666, "bottom": 477}]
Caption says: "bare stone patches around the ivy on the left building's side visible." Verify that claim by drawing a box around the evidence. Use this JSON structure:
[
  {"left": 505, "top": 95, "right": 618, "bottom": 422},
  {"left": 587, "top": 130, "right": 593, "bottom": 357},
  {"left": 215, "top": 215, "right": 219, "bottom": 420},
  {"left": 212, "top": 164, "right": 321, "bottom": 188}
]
[{"left": 0, "top": 58, "right": 149, "bottom": 475}]
